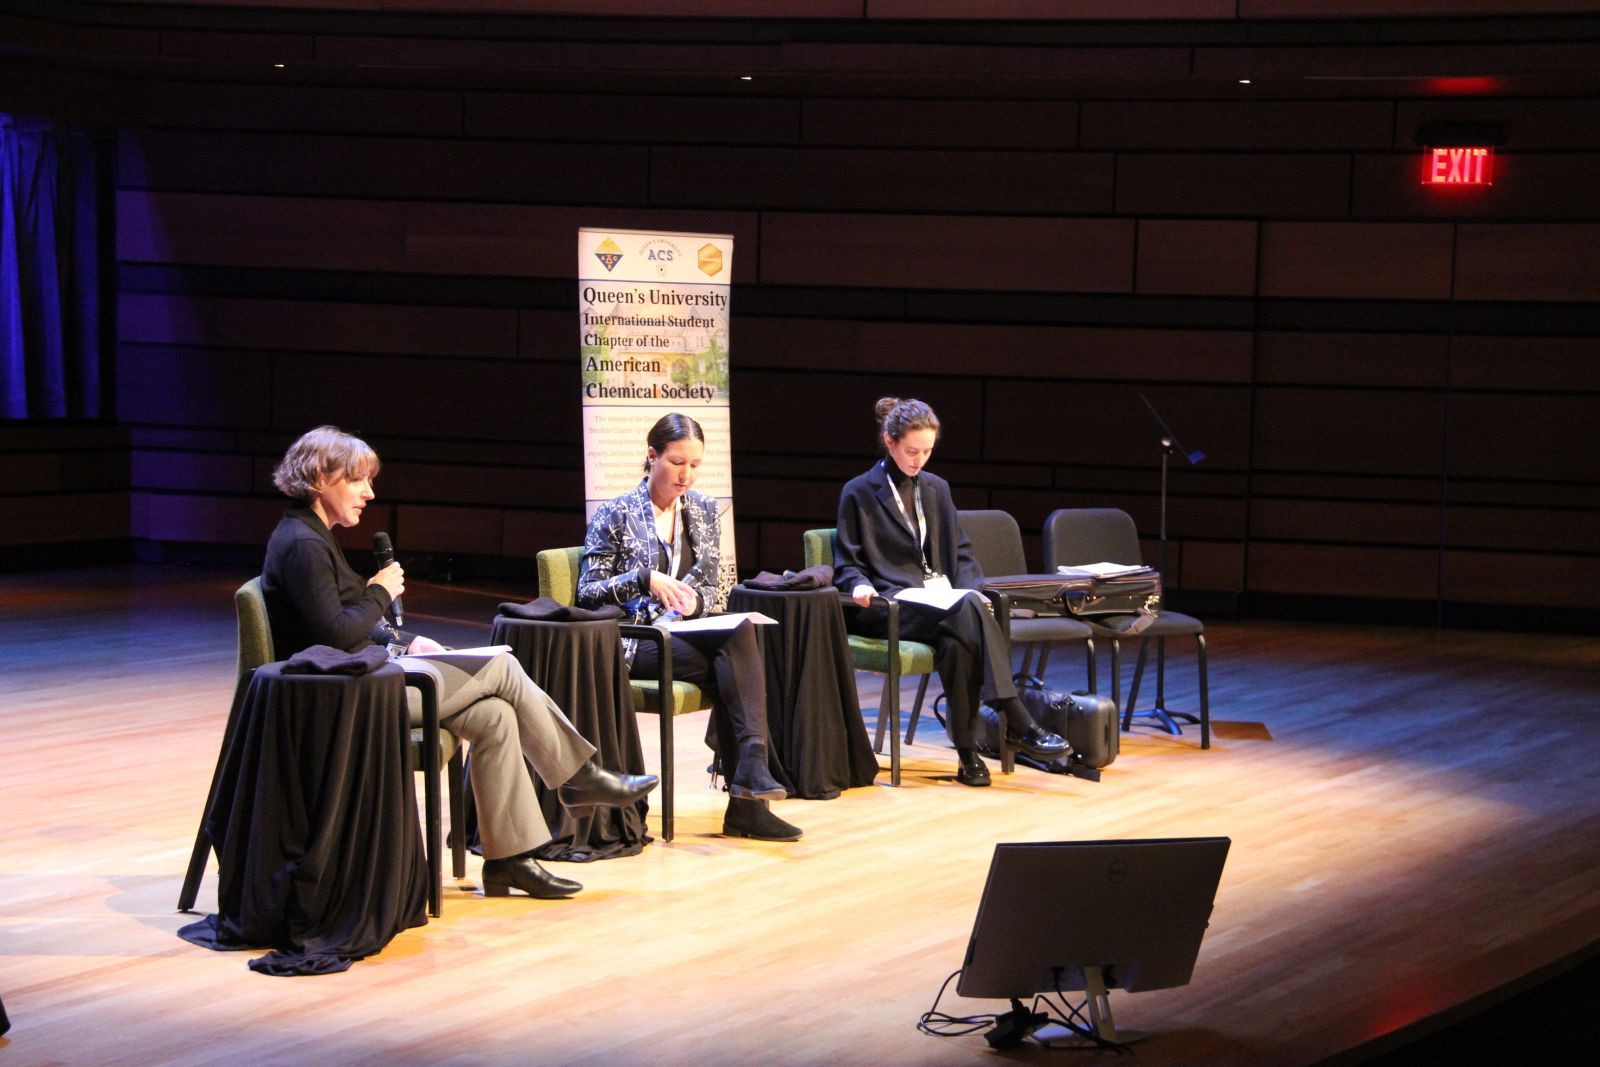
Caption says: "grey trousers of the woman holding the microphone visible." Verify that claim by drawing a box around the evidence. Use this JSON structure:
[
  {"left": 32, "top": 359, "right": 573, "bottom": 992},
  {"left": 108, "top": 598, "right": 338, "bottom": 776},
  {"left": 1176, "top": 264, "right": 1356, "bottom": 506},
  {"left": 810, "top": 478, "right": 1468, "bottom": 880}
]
[{"left": 397, "top": 653, "right": 595, "bottom": 859}]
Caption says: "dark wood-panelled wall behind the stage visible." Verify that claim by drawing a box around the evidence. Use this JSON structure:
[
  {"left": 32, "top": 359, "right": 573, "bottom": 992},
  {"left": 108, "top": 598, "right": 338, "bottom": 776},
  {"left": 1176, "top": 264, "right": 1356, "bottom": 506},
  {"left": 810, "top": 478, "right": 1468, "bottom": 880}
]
[{"left": 3, "top": 3, "right": 1600, "bottom": 621}]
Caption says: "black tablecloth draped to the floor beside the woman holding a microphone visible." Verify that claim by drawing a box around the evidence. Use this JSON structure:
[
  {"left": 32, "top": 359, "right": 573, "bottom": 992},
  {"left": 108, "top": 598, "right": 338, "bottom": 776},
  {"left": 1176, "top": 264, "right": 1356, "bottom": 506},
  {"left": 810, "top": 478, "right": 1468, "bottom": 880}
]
[{"left": 178, "top": 664, "right": 427, "bottom": 974}]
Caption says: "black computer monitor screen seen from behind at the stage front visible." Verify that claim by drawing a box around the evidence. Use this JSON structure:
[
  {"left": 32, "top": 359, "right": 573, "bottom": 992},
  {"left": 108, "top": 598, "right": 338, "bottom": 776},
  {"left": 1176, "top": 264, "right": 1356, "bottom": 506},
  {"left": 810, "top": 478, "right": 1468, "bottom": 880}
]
[{"left": 957, "top": 837, "right": 1229, "bottom": 998}]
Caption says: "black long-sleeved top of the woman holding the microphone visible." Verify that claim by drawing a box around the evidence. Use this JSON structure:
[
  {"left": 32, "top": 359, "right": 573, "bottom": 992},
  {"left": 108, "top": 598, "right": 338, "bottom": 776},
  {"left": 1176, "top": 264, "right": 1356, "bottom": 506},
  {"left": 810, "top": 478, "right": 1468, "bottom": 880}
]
[{"left": 261, "top": 504, "right": 406, "bottom": 659}]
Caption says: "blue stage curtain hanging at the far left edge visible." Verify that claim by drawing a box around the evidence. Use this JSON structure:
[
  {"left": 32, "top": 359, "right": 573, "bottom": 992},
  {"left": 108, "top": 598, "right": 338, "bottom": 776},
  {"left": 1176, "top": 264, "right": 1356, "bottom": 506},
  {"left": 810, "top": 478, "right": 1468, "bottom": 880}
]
[{"left": 0, "top": 114, "right": 101, "bottom": 419}]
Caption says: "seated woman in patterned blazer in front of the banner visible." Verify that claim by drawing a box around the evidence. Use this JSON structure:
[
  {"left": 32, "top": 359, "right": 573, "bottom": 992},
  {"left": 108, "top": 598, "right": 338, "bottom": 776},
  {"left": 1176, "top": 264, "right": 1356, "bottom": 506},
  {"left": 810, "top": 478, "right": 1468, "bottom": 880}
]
[{"left": 578, "top": 413, "right": 802, "bottom": 841}]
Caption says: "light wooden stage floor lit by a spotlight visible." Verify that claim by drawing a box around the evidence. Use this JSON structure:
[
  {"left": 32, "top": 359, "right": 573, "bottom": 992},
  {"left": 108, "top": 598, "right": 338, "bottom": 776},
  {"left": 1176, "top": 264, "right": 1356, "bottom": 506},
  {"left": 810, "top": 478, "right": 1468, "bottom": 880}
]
[{"left": 0, "top": 566, "right": 1600, "bottom": 1067}]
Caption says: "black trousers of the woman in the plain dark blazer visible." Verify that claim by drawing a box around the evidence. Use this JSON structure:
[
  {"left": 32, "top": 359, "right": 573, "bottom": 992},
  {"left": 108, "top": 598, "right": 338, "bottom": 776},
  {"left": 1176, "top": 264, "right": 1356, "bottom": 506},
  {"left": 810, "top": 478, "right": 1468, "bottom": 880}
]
[{"left": 851, "top": 597, "right": 1034, "bottom": 749}]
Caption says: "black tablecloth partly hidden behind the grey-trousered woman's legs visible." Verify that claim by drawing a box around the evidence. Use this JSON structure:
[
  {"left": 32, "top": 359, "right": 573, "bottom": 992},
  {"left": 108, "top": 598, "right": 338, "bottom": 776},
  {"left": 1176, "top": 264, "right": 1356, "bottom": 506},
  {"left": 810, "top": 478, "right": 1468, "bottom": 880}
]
[{"left": 486, "top": 616, "right": 650, "bottom": 862}]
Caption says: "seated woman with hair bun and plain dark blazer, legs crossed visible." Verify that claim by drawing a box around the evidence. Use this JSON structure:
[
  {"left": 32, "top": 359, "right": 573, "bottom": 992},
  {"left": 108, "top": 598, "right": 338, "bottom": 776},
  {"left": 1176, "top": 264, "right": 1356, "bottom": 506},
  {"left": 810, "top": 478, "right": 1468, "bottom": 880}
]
[{"left": 834, "top": 397, "right": 1067, "bottom": 785}]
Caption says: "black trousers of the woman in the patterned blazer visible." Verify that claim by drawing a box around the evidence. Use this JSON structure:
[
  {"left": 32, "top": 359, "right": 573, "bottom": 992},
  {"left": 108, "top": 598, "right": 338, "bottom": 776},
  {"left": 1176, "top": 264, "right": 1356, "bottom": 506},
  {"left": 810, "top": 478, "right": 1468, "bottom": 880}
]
[{"left": 629, "top": 619, "right": 771, "bottom": 779}]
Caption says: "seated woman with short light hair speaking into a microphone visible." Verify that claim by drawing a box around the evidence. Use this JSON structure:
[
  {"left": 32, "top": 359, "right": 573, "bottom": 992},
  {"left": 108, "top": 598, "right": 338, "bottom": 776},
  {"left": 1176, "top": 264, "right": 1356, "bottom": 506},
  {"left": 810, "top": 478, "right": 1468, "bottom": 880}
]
[{"left": 261, "top": 426, "right": 656, "bottom": 899}]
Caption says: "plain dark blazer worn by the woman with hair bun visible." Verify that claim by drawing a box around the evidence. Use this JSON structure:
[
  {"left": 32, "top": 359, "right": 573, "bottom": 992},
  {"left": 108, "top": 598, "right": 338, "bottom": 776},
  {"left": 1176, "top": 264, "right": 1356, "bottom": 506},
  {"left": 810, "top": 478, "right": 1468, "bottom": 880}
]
[{"left": 834, "top": 462, "right": 984, "bottom": 597}]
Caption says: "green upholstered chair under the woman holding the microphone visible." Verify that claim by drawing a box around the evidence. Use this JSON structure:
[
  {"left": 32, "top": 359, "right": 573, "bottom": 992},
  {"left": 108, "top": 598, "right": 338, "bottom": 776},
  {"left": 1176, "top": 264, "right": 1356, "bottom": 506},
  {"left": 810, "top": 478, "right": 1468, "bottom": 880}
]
[{"left": 178, "top": 577, "right": 467, "bottom": 917}]
